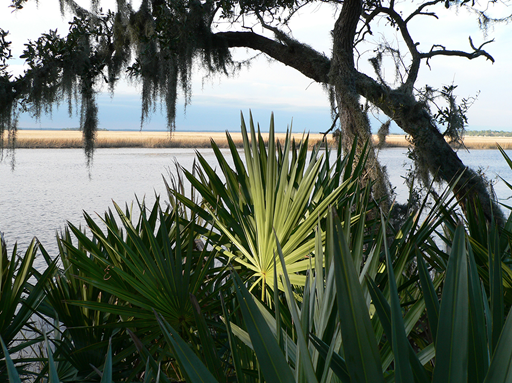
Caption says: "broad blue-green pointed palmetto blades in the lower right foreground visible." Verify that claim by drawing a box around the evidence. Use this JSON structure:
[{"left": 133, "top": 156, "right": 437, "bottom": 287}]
[{"left": 142, "top": 207, "right": 512, "bottom": 383}]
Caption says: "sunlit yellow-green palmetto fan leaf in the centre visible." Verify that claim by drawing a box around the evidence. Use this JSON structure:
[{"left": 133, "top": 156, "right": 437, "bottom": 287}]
[{"left": 178, "top": 112, "right": 357, "bottom": 298}]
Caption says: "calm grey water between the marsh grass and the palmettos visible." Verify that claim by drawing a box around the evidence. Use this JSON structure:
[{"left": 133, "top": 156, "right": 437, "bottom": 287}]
[{"left": 0, "top": 148, "right": 512, "bottom": 270}]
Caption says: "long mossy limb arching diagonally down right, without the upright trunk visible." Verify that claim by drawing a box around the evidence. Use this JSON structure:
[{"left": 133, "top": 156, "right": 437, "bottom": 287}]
[{"left": 215, "top": 21, "right": 500, "bottom": 219}]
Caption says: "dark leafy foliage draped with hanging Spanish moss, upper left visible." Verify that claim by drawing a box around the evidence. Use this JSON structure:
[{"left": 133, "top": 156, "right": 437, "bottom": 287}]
[{"left": 0, "top": 0, "right": 234, "bottom": 161}]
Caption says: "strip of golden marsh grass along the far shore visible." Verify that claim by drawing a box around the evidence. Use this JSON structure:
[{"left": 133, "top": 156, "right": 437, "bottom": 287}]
[{"left": 4, "top": 130, "right": 512, "bottom": 149}]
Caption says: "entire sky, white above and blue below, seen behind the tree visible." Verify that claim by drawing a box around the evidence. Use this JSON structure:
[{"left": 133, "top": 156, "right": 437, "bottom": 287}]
[{"left": 0, "top": 0, "right": 512, "bottom": 133}]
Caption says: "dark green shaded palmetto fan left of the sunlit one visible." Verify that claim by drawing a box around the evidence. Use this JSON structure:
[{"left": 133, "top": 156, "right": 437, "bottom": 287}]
[{"left": 49, "top": 199, "right": 227, "bottom": 376}]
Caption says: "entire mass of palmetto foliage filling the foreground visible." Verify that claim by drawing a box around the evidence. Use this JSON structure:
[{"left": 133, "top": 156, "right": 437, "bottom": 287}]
[{"left": 5, "top": 118, "right": 512, "bottom": 383}]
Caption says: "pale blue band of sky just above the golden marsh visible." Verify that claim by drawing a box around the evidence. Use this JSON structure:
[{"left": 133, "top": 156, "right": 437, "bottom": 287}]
[{"left": 19, "top": 94, "right": 332, "bottom": 133}]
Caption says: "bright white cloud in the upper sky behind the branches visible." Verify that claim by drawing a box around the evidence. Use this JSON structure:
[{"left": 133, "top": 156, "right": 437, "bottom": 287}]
[{"left": 0, "top": 0, "right": 512, "bottom": 129}]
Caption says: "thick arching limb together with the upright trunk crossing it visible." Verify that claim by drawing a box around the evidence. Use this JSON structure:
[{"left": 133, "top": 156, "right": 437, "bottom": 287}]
[{"left": 215, "top": 25, "right": 504, "bottom": 223}]
